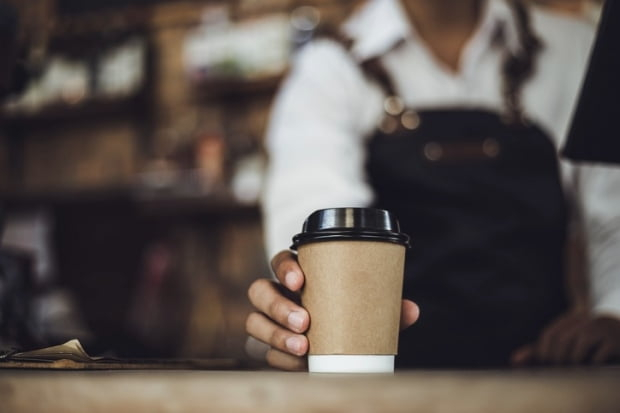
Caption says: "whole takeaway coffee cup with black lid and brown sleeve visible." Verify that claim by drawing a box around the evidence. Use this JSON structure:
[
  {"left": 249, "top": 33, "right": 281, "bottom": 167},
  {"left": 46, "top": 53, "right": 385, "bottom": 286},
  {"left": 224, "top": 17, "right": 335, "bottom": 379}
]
[{"left": 291, "top": 208, "right": 409, "bottom": 373}]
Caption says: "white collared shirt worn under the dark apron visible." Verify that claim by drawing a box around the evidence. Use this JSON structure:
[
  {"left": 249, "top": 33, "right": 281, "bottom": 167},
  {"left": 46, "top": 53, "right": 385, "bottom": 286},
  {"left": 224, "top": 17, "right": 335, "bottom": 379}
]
[{"left": 263, "top": 0, "right": 620, "bottom": 315}]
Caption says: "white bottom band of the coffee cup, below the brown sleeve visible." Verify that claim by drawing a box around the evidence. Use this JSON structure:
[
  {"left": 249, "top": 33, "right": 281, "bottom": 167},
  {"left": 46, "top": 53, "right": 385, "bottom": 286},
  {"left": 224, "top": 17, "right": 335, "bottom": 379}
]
[{"left": 308, "top": 354, "right": 394, "bottom": 373}]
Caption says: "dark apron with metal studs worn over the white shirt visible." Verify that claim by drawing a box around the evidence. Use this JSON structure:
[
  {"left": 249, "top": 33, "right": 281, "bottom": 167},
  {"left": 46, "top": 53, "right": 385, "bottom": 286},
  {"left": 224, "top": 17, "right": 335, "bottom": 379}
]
[{"left": 362, "top": 68, "right": 567, "bottom": 367}]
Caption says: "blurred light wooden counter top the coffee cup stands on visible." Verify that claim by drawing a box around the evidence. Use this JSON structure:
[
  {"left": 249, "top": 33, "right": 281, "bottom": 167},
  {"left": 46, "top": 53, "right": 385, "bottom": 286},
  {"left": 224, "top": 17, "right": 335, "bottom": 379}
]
[{"left": 0, "top": 367, "right": 620, "bottom": 413}]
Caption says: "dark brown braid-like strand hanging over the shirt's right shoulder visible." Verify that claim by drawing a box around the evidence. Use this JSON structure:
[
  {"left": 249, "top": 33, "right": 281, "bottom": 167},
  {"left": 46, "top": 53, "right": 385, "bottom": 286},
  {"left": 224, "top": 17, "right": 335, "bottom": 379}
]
[{"left": 502, "top": 0, "right": 543, "bottom": 123}]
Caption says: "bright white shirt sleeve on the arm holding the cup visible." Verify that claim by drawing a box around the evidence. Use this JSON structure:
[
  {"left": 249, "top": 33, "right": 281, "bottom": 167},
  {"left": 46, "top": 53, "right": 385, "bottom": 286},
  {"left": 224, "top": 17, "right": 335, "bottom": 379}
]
[{"left": 262, "top": 40, "right": 377, "bottom": 257}]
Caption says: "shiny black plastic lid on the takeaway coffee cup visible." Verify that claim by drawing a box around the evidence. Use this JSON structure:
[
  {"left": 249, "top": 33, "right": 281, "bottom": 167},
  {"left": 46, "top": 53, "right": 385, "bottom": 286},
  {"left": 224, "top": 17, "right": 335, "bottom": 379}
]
[{"left": 291, "top": 208, "right": 410, "bottom": 249}]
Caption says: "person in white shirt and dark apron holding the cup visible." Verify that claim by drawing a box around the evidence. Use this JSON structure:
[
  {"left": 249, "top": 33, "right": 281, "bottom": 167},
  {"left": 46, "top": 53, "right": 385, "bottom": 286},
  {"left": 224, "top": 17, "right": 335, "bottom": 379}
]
[{"left": 247, "top": 0, "right": 620, "bottom": 369}]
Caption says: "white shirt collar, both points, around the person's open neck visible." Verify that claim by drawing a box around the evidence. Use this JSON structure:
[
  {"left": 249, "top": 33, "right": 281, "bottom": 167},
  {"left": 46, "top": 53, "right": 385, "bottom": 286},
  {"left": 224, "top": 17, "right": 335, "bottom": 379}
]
[{"left": 343, "top": 0, "right": 519, "bottom": 61}]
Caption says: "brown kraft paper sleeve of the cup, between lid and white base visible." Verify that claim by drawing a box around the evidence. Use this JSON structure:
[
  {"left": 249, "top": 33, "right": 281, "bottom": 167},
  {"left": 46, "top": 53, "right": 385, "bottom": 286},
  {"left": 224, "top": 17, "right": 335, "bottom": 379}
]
[{"left": 298, "top": 240, "right": 406, "bottom": 355}]
